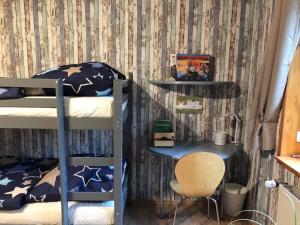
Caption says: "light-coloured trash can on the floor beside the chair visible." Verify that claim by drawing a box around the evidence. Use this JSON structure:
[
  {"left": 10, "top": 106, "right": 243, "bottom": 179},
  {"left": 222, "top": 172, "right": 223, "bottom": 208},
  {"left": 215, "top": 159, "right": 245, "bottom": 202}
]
[{"left": 224, "top": 183, "right": 248, "bottom": 216}]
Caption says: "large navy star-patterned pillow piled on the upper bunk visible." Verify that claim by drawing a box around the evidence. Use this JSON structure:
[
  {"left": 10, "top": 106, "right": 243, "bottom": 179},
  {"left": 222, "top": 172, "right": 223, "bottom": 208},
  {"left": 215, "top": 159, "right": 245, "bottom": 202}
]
[{"left": 27, "top": 62, "right": 126, "bottom": 96}]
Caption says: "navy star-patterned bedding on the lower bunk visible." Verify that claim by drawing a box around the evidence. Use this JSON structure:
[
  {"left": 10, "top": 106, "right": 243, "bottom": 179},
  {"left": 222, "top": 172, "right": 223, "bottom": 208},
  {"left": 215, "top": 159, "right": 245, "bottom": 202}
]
[{"left": 0, "top": 156, "right": 126, "bottom": 210}]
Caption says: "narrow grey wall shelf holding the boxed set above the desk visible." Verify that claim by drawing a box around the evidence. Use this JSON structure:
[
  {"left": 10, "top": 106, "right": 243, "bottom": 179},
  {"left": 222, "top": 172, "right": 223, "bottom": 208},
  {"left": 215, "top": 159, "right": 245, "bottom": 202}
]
[{"left": 149, "top": 80, "right": 234, "bottom": 86}]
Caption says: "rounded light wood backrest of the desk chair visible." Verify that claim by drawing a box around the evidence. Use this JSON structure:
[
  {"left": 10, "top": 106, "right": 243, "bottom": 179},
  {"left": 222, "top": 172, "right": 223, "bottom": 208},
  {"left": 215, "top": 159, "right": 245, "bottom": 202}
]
[{"left": 175, "top": 152, "right": 225, "bottom": 197}]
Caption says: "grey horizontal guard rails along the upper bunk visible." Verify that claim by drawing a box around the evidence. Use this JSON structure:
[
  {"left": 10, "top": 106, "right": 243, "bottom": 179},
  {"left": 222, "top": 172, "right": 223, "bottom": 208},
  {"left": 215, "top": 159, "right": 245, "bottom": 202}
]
[{"left": 0, "top": 78, "right": 130, "bottom": 129}]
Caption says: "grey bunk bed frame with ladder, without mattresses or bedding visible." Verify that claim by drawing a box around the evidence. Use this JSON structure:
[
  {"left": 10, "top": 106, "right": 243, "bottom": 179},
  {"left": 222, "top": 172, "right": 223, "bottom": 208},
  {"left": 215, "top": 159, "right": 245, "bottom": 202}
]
[{"left": 0, "top": 78, "right": 130, "bottom": 225}]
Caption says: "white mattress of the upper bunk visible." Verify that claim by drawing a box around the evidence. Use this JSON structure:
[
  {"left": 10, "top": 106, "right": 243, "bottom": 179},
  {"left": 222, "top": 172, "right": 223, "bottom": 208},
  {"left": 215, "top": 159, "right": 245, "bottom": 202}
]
[{"left": 0, "top": 96, "right": 127, "bottom": 117}]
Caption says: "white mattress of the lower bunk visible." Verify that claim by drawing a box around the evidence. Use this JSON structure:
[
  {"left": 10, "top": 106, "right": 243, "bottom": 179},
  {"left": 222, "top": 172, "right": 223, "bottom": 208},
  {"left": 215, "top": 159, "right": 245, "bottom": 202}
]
[{"left": 0, "top": 201, "right": 114, "bottom": 225}]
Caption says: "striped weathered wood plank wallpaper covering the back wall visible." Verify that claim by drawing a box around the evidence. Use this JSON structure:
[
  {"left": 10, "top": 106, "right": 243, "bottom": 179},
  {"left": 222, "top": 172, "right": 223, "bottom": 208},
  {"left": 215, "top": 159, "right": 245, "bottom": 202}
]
[{"left": 0, "top": 0, "right": 290, "bottom": 215}]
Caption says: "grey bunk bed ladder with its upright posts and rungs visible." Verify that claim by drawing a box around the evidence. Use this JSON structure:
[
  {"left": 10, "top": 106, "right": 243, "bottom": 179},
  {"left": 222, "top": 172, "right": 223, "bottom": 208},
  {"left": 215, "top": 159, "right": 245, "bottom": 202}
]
[{"left": 56, "top": 80, "right": 129, "bottom": 225}]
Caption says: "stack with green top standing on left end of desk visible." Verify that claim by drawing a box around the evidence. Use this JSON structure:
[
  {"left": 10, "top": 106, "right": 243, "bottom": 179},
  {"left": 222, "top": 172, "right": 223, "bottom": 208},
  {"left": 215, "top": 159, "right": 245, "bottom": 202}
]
[{"left": 154, "top": 120, "right": 175, "bottom": 147}]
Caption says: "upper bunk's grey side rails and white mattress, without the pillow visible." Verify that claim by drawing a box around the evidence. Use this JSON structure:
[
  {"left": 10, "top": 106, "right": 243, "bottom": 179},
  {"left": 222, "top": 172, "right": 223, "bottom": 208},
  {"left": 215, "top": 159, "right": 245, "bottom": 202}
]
[{"left": 0, "top": 78, "right": 130, "bottom": 129}]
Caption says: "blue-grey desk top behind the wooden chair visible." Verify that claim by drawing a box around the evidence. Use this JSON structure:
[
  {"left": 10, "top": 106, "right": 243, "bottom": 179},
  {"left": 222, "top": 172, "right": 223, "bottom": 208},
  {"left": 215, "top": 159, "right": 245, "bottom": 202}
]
[{"left": 149, "top": 142, "right": 242, "bottom": 160}]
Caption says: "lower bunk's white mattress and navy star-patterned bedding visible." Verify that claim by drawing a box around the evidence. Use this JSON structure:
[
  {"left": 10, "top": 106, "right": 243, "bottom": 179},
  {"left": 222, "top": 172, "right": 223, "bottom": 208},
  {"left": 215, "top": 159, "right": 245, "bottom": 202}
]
[{"left": 0, "top": 158, "right": 128, "bottom": 225}]
